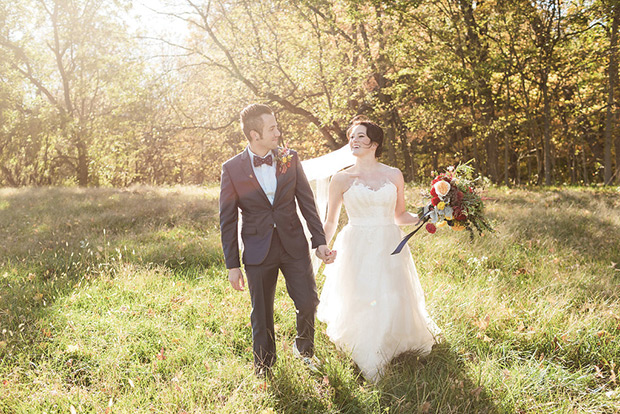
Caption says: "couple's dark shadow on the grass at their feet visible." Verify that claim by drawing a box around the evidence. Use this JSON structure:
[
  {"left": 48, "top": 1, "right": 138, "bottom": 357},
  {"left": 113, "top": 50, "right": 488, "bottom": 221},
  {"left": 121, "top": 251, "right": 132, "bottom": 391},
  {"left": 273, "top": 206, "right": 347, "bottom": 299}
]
[{"left": 271, "top": 343, "right": 499, "bottom": 414}]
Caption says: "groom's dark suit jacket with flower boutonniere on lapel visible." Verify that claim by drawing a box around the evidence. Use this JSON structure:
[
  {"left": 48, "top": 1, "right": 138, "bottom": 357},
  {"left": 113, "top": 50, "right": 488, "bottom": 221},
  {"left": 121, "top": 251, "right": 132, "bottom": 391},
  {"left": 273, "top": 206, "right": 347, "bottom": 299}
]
[{"left": 220, "top": 149, "right": 326, "bottom": 269}]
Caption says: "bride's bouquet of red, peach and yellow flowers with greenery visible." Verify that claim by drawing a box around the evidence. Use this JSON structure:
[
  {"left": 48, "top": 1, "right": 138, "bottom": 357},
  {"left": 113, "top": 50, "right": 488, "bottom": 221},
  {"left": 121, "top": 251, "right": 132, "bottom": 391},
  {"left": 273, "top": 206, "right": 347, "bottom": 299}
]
[{"left": 418, "top": 163, "right": 493, "bottom": 239}]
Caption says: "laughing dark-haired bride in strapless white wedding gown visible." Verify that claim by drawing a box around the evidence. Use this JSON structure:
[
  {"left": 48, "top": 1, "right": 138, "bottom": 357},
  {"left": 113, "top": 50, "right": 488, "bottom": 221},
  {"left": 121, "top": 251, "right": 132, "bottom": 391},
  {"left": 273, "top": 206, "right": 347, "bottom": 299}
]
[{"left": 317, "top": 116, "right": 439, "bottom": 381}]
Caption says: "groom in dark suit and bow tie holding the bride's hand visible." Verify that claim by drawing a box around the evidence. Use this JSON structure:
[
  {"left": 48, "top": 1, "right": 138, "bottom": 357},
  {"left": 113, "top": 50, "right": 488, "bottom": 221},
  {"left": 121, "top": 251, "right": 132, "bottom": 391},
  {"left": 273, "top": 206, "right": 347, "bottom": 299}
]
[{"left": 220, "top": 104, "right": 336, "bottom": 376}]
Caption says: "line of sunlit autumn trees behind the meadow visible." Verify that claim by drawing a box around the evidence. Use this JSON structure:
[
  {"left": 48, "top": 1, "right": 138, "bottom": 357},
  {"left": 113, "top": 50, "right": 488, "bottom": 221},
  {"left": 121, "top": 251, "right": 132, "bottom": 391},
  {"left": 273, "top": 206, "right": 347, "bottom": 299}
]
[{"left": 0, "top": 0, "right": 620, "bottom": 186}]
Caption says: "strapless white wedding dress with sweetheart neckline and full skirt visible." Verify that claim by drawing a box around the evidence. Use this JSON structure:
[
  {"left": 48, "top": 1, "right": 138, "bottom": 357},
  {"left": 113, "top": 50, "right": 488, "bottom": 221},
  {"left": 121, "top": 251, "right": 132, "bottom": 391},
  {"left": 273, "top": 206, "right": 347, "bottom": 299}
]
[{"left": 317, "top": 179, "right": 439, "bottom": 381}]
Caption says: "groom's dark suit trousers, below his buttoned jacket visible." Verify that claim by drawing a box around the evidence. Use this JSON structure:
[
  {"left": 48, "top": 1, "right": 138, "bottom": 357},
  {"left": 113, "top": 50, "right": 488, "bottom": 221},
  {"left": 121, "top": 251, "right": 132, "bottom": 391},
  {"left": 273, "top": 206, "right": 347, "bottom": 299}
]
[{"left": 245, "top": 229, "right": 319, "bottom": 369}]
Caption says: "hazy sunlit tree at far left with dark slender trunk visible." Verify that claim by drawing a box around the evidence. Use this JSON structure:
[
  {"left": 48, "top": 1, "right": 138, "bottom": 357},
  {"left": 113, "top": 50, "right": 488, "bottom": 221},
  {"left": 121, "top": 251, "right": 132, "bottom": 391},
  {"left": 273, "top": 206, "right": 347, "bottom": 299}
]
[{"left": 0, "top": 0, "right": 134, "bottom": 186}]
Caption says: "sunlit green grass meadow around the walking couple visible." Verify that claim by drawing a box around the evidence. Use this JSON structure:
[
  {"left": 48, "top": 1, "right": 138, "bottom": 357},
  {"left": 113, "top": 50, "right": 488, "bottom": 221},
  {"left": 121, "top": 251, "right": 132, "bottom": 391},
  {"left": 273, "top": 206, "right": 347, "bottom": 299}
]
[{"left": 0, "top": 187, "right": 620, "bottom": 413}]
